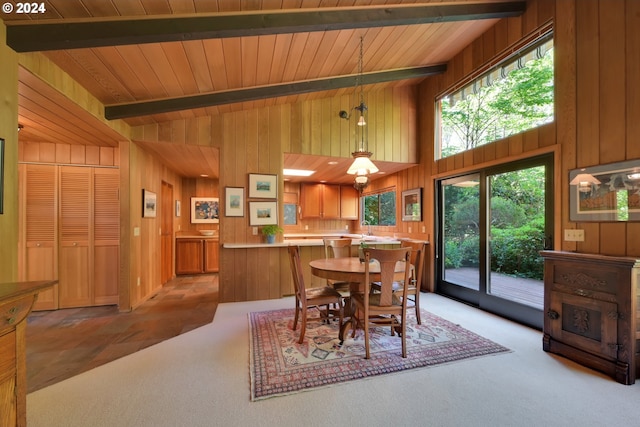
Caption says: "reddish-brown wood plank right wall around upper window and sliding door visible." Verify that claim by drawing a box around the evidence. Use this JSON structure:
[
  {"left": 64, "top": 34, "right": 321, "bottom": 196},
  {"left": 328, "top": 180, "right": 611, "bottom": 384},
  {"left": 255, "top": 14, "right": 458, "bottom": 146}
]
[{"left": 416, "top": 0, "right": 640, "bottom": 270}]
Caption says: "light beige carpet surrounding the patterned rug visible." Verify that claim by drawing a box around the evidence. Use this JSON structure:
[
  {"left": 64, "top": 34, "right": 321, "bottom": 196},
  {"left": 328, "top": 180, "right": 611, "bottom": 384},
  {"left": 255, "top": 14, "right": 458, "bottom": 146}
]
[{"left": 27, "top": 294, "right": 640, "bottom": 427}]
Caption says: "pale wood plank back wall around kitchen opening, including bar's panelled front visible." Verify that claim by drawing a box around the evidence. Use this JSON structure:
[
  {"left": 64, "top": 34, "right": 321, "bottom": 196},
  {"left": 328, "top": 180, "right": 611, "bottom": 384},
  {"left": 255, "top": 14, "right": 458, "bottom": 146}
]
[{"left": 132, "top": 88, "right": 417, "bottom": 302}]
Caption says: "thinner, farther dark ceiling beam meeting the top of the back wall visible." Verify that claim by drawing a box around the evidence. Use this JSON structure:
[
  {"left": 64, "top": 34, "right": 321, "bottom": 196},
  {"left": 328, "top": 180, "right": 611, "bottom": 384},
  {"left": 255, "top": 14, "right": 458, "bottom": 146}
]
[{"left": 104, "top": 65, "right": 447, "bottom": 120}]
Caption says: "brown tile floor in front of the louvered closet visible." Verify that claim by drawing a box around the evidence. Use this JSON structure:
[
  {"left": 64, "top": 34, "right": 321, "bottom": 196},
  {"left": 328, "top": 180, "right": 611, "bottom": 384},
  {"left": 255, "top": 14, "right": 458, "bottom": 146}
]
[{"left": 27, "top": 274, "right": 218, "bottom": 393}]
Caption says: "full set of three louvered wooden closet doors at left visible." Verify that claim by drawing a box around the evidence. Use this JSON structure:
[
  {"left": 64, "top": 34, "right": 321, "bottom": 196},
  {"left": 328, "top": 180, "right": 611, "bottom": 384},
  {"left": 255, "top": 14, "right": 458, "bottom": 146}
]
[{"left": 19, "top": 164, "right": 120, "bottom": 310}]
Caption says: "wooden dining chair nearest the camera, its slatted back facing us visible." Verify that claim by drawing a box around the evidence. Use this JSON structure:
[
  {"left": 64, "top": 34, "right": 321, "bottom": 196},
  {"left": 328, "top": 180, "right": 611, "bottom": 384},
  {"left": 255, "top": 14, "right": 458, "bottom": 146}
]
[{"left": 351, "top": 248, "right": 411, "bottom": 359}]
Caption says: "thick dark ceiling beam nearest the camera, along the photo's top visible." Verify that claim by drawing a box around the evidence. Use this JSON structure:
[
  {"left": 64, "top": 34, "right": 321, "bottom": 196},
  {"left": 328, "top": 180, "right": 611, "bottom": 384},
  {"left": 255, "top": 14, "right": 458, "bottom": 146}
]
[{"left": 6, "top": 1, "right": 526, "bottom": 52}]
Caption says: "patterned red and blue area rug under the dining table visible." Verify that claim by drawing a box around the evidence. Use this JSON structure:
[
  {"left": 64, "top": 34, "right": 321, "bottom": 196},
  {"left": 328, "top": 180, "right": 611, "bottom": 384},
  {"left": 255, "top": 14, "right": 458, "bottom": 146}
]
[{"left": 249, "top": 309, "right": 510, "bottom": 401}]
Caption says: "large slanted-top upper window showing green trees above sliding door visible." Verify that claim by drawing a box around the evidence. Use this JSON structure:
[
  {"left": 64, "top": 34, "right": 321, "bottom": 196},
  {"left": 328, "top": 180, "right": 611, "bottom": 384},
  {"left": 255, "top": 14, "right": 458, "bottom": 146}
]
[{"left": 436, "top": 34, "right": 554, "bottom": 159}]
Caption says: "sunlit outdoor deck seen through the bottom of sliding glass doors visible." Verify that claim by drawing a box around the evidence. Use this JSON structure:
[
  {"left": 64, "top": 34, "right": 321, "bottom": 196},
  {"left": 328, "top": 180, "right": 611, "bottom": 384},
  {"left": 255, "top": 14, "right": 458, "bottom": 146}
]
[{"left": 446, "top": 268, "right": 544, "bottom": 310}]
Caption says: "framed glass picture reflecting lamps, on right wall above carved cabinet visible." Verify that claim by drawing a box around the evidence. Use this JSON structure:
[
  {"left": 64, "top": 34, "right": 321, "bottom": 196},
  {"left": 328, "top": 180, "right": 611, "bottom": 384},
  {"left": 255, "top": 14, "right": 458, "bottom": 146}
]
[{"left": 569, "top": 159, "right": 640, "bottom": 221}]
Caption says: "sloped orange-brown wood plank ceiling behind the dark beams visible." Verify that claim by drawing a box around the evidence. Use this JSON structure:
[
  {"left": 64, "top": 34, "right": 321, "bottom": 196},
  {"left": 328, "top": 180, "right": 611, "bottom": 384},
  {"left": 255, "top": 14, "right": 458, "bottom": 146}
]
[{"left": 2, "top": 0, "right": 526, "bottom": 182}]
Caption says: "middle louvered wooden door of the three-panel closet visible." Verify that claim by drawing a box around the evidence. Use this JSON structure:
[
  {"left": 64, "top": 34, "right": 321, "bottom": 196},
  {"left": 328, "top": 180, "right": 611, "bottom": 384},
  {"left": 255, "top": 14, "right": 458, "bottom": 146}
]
[{"left": 58, "top": 166, "right": 93, "bottom": 308}]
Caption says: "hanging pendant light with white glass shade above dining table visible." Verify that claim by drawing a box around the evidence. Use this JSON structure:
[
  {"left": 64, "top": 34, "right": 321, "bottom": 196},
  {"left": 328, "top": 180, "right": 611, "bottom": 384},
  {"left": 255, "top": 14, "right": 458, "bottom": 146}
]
[{"left": 340, "top": 36, "right": 378, "bottom": 192}]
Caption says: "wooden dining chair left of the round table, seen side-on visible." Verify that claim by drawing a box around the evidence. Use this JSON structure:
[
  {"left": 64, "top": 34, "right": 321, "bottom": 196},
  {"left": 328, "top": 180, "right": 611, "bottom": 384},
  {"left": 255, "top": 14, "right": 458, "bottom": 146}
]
[{"left": 289, "top": 246, "right": 344, "bottom": 344}]
